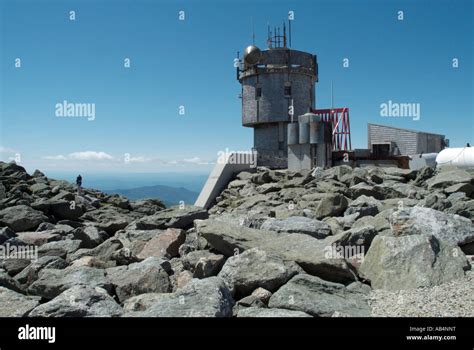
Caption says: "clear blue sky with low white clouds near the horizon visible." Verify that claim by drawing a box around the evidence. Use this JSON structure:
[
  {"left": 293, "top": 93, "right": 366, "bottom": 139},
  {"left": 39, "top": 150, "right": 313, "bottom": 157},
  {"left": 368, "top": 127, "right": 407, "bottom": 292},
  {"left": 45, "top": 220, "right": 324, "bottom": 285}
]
[{"left": 0, "top": 0, "right": 474, "bottom": 172}]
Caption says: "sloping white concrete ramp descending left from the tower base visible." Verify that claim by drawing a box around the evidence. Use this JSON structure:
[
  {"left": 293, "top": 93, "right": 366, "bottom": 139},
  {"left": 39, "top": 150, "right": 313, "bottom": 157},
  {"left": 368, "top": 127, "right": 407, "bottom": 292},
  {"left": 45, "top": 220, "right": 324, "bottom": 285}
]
[{"left": 194, "top": 152, "right": 255, "bottom": 209}]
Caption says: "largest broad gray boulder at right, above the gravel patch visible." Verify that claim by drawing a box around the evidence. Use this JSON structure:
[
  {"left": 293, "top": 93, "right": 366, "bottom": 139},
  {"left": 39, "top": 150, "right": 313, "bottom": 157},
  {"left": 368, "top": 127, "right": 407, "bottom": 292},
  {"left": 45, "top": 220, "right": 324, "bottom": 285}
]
[{"left": 359, "top": 234, "right": 469, "bottom": 290}]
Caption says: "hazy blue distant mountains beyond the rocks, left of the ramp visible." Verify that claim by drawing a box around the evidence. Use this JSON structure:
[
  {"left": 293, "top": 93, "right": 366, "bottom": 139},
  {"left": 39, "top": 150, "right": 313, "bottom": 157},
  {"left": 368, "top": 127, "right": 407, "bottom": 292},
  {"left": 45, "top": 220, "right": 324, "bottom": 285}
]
[{"left": 104, "top": 185, "right": 199, "bottom": 207}]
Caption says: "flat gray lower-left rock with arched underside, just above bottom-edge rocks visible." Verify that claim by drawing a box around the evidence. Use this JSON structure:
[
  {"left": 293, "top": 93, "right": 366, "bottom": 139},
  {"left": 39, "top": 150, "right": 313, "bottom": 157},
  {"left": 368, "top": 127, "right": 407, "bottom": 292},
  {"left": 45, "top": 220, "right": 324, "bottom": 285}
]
[{"left": 28, "top": 266, "right": 112, "bottom": 299}]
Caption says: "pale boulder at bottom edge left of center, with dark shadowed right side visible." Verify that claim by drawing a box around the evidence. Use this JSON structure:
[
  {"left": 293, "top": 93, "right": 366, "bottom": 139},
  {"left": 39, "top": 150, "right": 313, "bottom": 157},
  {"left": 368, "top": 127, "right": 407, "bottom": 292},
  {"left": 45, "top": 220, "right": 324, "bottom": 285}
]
[{"left": 125, "top": 277, "right": 234, "bottom": 317}]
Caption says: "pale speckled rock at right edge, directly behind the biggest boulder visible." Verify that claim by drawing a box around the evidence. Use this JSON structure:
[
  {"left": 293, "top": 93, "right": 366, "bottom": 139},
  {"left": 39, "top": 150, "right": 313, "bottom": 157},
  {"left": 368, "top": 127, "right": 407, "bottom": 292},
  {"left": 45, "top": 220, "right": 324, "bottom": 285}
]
[{"left": 390, "top": 207, "right": 474, "bottom": 245}]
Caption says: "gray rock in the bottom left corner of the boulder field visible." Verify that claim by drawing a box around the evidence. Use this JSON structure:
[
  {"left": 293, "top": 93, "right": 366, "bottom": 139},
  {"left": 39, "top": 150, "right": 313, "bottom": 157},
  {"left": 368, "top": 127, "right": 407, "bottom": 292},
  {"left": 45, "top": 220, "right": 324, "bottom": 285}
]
[{"left": 0, "top": 287, "right": 40, "bottom": 317}]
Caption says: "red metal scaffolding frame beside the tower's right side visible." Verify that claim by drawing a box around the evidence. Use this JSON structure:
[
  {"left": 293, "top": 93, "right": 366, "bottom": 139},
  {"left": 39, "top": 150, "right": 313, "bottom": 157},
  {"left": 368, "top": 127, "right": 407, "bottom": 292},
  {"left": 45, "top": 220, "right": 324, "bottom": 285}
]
[{"left": 311, "top": 107, "right": 352, "bottom": 151}]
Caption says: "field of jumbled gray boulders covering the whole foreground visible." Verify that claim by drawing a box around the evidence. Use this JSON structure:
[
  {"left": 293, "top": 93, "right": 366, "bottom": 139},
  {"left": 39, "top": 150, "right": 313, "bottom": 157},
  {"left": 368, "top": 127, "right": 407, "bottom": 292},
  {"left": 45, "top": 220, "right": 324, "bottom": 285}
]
[{"left": 0, "top": 163, "right": 474, "bottom": 317}]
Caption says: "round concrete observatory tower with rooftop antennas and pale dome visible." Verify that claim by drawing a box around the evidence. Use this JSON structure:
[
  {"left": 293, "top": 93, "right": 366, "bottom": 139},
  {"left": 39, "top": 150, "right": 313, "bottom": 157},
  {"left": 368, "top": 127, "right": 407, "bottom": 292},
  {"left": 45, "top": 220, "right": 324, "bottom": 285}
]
[{"left": 237, "top": 25, "right": 318, "bottom": 168}]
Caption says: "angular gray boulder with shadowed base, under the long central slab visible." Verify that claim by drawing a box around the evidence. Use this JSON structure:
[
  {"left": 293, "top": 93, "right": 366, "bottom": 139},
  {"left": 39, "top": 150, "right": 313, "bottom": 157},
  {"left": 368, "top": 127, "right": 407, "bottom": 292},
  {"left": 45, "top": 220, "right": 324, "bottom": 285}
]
[{"left": 218, "top": 248, "right": 299, "bottom": 296}]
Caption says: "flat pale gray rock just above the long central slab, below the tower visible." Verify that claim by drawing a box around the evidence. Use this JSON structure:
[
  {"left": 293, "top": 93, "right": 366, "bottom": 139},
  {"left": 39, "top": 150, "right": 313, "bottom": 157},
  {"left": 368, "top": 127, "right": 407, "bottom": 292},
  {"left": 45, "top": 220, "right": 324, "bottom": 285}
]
[{"left": 261, "top": 216, "right": 331, "bottom": 238}]
